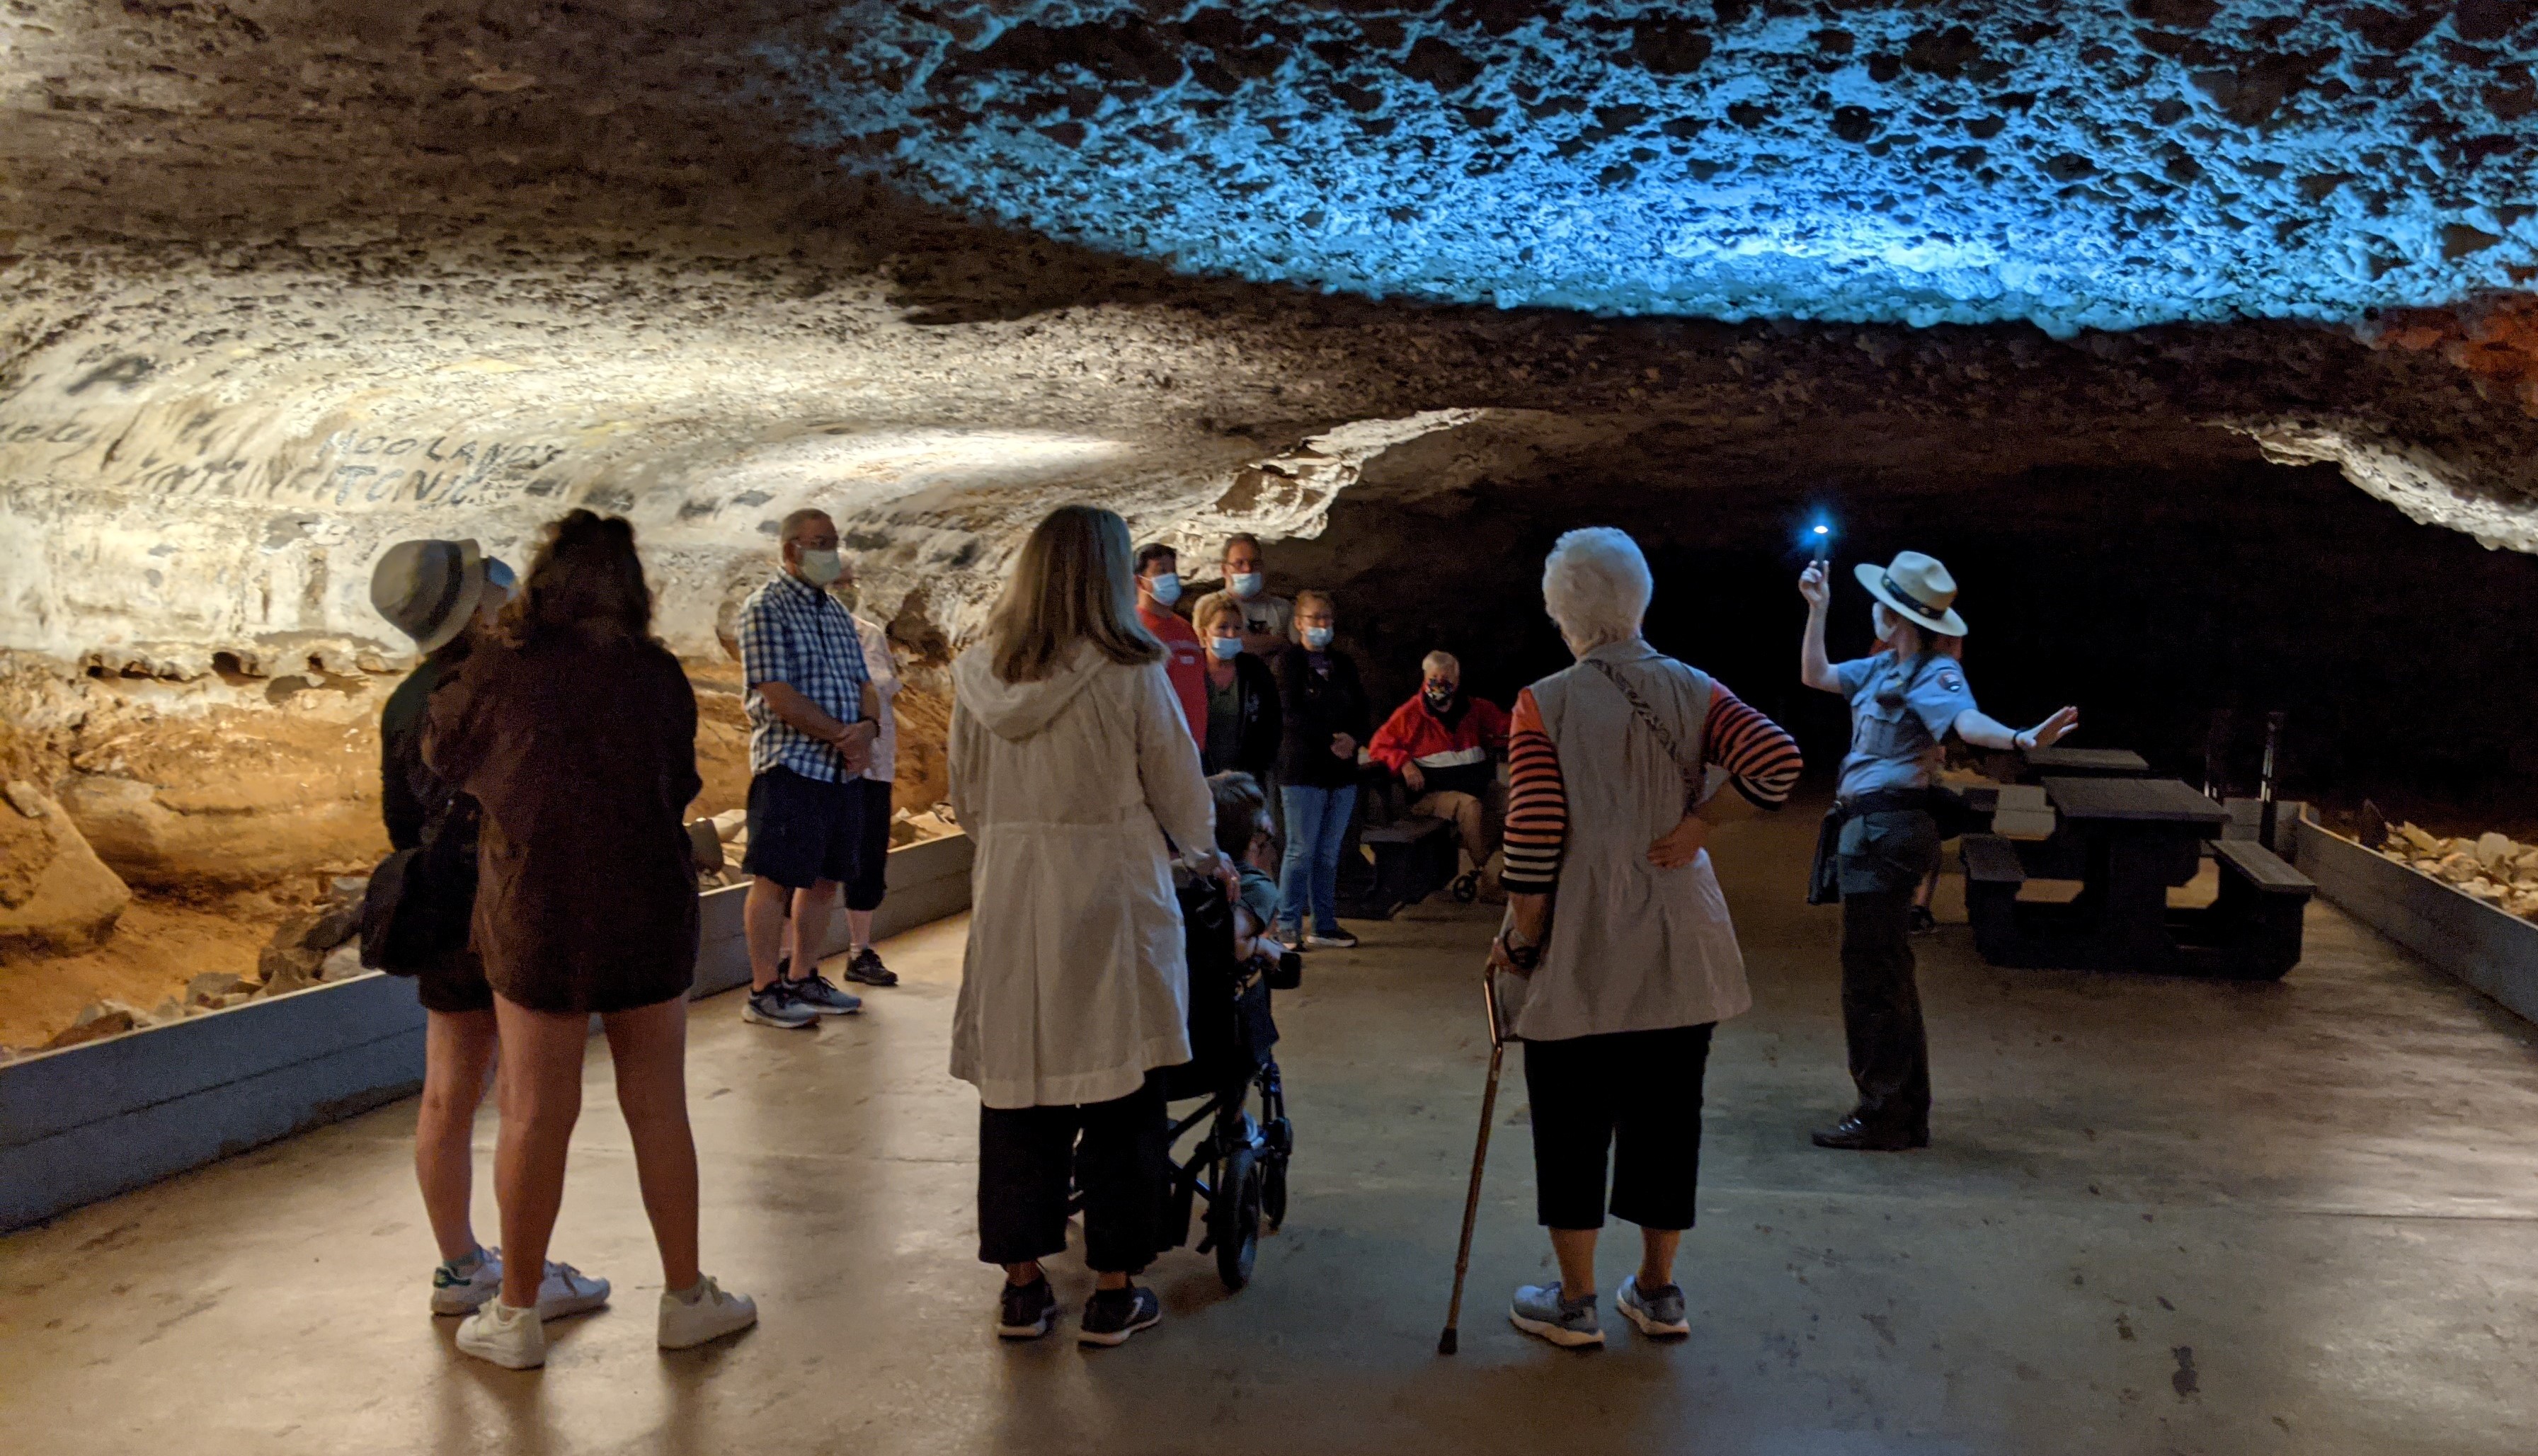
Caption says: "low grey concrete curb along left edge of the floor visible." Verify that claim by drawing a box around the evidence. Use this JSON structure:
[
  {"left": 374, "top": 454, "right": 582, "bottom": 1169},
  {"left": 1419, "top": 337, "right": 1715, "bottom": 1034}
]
[{"left": 0, "top": 835, "right": 972, "bottom": 1230}]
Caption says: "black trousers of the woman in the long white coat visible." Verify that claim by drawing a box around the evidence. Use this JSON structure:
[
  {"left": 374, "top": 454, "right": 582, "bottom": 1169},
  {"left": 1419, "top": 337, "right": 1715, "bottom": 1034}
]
[{"left": 977, "top": 1070, "right": 1172, "bottom": 1273}]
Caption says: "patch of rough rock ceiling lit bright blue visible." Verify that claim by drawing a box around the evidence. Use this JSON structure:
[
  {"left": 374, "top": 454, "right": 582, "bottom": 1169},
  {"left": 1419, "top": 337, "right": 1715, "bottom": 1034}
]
[{"left": 782, "top": 0, "right": 2538, "bottom": 335}]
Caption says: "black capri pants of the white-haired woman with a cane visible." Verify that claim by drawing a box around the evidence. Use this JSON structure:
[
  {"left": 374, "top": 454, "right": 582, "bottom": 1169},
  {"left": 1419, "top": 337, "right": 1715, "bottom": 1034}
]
[{"left": 1526, "top": 1022, "right": 1715, "bottom": 1230}]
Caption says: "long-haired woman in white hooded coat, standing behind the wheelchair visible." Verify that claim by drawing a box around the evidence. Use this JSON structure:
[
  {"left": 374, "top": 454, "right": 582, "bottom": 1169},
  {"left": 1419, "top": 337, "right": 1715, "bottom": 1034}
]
[{"left": 951, "top": 505, "right": 1216, "bottom": 1344}]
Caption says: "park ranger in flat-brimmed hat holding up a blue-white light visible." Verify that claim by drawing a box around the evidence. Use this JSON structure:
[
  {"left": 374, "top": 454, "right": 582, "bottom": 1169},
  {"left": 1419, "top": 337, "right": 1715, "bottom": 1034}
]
[{"left": 1797, "top": 551, "right": 2079, "bottom": 1152}]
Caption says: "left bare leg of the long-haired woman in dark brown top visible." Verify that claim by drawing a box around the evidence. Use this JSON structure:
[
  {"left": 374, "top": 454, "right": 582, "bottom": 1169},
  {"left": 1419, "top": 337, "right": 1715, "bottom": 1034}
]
[{"left": 492, "top": 992, "right": 591, "bottom": 1309}]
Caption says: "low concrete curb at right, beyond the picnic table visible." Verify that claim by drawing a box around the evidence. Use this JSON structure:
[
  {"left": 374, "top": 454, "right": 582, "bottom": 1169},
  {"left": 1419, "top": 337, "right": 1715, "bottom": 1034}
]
[{"left": 2297, "top": 820, "right": 2538, "bottom": 1022}]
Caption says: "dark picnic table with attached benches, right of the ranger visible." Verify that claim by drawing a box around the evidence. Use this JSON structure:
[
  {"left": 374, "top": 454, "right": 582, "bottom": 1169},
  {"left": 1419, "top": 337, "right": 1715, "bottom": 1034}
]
[{"left": 1965, "top": 776, "right": 2312, "bottom": 979}]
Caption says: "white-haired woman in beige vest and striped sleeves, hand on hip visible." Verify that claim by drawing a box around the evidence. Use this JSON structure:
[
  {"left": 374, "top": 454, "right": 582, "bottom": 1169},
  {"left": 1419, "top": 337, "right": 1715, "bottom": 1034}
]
[{"left": 1490, "top": 527, "right": 1800, "bottom": 1344}]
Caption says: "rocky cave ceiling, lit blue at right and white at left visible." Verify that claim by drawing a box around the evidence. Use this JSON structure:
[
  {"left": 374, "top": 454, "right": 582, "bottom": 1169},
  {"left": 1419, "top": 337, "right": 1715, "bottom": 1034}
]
[{"left": 0, "top": 0, "right": 2538, "bottom": 672}]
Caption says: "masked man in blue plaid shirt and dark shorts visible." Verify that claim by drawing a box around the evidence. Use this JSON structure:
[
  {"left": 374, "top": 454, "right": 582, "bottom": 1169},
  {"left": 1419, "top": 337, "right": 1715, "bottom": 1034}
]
[{"left": 741, "top": 510, "right": 888, "bottom": 1027}]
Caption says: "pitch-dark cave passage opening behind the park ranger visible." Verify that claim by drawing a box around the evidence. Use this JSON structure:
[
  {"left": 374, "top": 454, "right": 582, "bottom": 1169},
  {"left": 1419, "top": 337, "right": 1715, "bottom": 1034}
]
[{"left": 1271, "top": 447, "right": 2538, "bottom": 835}]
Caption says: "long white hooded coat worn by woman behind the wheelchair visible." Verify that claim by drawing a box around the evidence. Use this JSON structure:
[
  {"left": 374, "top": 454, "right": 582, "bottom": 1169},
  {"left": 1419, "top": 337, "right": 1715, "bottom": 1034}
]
[{"left": 951, "top": 644, "right": 1216, "bottom": 1108}]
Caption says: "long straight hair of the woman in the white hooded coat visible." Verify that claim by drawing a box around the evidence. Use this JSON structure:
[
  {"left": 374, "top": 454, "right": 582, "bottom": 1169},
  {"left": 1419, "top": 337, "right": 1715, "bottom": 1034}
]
[{"left": 988, "top": 505, "right": 1162, "bottom": 682}]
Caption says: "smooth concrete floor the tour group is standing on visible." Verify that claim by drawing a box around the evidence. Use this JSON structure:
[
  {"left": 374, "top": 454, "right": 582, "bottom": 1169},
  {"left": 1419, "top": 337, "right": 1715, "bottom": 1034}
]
[{"left": 0, "top": 814, "right": 2538, "bottom": 1456}]
